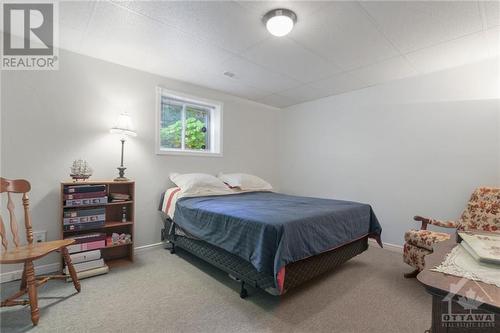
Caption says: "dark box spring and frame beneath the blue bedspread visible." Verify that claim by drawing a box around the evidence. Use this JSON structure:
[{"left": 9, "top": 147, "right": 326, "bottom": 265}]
[{"left": 162, "top": 218, "right": 368, "bottom": 298}]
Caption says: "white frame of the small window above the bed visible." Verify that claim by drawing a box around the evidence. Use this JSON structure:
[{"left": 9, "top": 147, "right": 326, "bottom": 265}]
[{"left": 155, "top": 87, "right": 224, "bottom": 157}]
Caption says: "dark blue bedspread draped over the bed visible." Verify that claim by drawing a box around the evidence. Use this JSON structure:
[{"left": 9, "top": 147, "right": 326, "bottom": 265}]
[{"left": 174, "top": 192, "right": 382, "bottom": 278}]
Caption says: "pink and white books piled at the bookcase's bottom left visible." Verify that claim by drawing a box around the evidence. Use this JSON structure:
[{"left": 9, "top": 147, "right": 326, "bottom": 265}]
[{"left": 64, "top": 233, "right": 109, "bottom": 281}]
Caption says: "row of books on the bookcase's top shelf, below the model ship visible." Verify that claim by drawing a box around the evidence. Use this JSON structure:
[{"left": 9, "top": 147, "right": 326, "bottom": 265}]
[{"left": 64, "top": 184, "right": 108, "bottom": 207}]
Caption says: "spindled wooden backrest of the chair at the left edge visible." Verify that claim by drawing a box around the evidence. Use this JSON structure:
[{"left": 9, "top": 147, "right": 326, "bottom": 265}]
[{"left": 0, "top": 178, "right": 33, "bottom": 251}]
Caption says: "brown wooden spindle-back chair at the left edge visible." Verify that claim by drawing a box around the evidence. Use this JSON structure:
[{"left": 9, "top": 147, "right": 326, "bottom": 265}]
[{"left": 0, "top": 178, "right": 80, "bottom": 325}]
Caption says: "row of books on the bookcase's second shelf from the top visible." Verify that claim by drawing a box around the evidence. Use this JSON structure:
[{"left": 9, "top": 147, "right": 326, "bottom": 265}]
[{"left": 63, "top": 207, "right": 106, "bottom": 231}]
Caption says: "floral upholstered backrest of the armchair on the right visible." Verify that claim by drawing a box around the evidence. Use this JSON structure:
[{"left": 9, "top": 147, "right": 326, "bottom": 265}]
[{"left": 458, "top": 187, "right": 500, "bottom": 232}]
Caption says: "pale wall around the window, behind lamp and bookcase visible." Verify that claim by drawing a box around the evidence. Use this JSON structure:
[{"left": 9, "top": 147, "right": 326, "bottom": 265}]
[{"left": 1, "top": 50, "right": 279, "bottom": 270}]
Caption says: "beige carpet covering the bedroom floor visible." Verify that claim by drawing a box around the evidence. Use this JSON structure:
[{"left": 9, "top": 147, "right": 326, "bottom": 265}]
[{"left": 0, "top": 247, "right": 431, "bottom": 333}]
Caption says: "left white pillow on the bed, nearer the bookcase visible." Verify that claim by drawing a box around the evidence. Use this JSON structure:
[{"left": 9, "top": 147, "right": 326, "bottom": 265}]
[{"left": 170, "top": 173, "right": 233, "bottom": 197}]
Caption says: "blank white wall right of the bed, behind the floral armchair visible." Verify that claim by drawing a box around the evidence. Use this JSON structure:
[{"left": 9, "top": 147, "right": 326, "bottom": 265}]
[{"left": 279, "top": 59, "right": 500, "bottom": 245}]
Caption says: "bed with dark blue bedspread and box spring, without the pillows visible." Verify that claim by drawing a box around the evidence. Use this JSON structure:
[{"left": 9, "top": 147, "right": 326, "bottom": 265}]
[{"left": 160, "top": 188, "right": 382, "bottom": 298}]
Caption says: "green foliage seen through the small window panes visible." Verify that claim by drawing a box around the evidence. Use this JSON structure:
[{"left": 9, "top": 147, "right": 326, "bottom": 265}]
[{"left": 160, "top": 117, "right": 207, "bottom": 150}]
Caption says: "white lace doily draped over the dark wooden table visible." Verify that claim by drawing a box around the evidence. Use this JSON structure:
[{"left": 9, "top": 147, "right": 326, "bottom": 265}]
[{"left": 431, "top": 245, "right": 500, "bottom": 287}]
